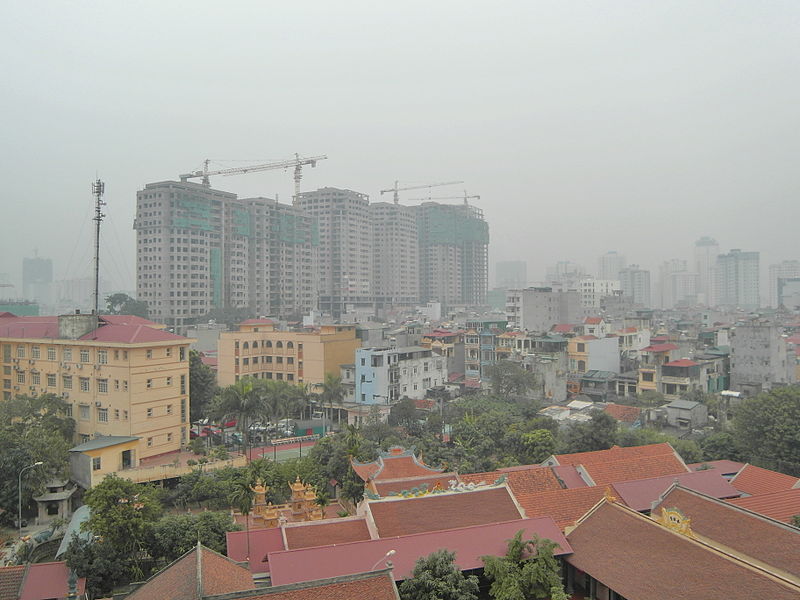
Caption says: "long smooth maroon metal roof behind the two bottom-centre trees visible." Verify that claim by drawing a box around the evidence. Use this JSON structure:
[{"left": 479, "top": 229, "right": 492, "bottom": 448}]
[{"left": 269, "top": 517, "right": 571, "bottom": 584}]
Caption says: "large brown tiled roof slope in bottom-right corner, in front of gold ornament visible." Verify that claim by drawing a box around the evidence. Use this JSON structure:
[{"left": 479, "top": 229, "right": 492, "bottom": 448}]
[{"left": 565, "top": 502, "right": 800, "bottom": 600}]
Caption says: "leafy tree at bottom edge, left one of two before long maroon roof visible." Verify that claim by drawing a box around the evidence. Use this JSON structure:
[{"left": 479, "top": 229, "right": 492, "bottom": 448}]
[{"left": 399, "top": 550, "right": 478, "bottom": 600}]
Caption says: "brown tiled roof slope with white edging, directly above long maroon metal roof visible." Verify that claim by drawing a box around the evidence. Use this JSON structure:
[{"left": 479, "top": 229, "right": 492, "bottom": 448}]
[{"left": 367, "top": 487, "right": 523, "bottom": 538}]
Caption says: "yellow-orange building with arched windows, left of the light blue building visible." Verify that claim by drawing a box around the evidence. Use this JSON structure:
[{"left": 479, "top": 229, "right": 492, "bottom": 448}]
[{"left": 217, "top": 319, "right": 361, "bottom": 386}]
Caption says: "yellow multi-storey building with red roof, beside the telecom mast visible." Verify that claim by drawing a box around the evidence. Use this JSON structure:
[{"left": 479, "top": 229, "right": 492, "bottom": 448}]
[{"left": 0, "top": 313, "right": 192, "bottom": 468}]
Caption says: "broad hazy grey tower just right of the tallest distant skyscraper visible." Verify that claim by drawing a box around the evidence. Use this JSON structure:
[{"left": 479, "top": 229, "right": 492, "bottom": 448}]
[{"left": 714, "top": 249, "right": 759, "bottom": 310}]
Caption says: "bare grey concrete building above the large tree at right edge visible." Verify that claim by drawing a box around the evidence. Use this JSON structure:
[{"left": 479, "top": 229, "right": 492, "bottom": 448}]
[{"left": 731, "top": 321, "right": 797, "bottom": 395}]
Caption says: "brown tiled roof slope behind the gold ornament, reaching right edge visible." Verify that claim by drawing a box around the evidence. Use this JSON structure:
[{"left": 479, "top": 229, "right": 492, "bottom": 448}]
[{"left": 648, "top": 487, "right": 800, "bottom": 580}]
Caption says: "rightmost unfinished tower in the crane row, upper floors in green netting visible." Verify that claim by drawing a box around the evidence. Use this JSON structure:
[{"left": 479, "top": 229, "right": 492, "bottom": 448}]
[{"left": 413, "top": 202, "right": 489, "bottom": 306}]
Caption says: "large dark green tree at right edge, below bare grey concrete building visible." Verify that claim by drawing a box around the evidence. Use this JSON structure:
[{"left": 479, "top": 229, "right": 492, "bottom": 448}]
[{"left": 733, "top": 385, "right": 800, "bottom": 476}]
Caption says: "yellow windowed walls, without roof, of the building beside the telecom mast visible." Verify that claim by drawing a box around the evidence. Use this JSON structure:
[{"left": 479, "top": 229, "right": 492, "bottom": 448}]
[{"left": 0, "top": 322, "right": 192, "bottom": 462}]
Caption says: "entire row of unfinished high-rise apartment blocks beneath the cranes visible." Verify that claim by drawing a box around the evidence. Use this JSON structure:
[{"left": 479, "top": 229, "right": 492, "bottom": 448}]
[{"left": 134, "top": 181, "right": 489, "bottom": 331}]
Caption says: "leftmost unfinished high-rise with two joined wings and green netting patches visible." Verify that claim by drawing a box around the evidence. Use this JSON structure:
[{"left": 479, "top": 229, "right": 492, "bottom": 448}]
[{"left": 134, "top": 181, "right": 316, "bottom": 331}]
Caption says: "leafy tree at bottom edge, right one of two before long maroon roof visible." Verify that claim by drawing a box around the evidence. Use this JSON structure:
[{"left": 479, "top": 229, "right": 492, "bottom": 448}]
[{"left": 481, "top": 531, "right": 568, "bottom": 600}]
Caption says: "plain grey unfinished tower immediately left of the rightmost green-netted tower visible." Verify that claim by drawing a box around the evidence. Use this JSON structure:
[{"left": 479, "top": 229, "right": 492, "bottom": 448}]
[{"left": 369, "top": 202, "right": 419, "bottom": 306}]
